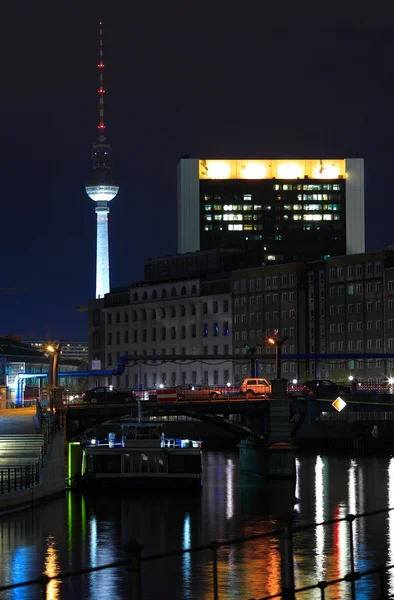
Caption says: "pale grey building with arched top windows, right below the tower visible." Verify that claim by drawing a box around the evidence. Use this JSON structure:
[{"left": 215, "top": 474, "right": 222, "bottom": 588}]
[{"left": 91, "top": 277, "right": 233, "bottom": 389}]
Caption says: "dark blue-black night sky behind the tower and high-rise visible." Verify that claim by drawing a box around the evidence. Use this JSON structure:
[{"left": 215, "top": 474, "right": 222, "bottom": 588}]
[{"left": 0, "top": 0, "right": 394, "bottom": 340}]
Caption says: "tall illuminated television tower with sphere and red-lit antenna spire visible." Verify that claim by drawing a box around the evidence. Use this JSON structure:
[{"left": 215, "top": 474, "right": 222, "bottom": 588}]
[{"left": 85, "top": 22, "right": 119, "bottom": 298}]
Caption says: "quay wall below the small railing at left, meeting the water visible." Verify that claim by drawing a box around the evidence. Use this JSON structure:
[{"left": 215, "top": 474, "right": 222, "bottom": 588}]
[{"left": 0, "top": 431, "right": 66, "bottom": 514}]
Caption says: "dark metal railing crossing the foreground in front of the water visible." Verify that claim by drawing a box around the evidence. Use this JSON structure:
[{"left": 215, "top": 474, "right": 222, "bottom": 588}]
[{"left": 0, "top": 508, "right": 394, "bottom": 600}]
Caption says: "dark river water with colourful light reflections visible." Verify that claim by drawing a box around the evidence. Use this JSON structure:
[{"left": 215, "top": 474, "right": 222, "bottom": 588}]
[{"left": 0, "top": 452, "right": 394, "bottom": 600}]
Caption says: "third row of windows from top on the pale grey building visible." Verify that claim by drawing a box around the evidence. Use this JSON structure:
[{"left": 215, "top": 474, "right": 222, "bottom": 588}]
[{"left": 107, "top": 322, "right": 230, "bottom": 345}]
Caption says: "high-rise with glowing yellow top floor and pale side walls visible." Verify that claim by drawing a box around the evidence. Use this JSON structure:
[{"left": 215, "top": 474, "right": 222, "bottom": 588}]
[{"left": 177, "top": 158, "right": 365, "bottom": 266}]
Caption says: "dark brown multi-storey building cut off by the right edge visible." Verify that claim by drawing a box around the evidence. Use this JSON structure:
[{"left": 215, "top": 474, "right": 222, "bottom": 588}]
[{"left": 308, "top": 248, "right": 394, "bottom": 381}]
